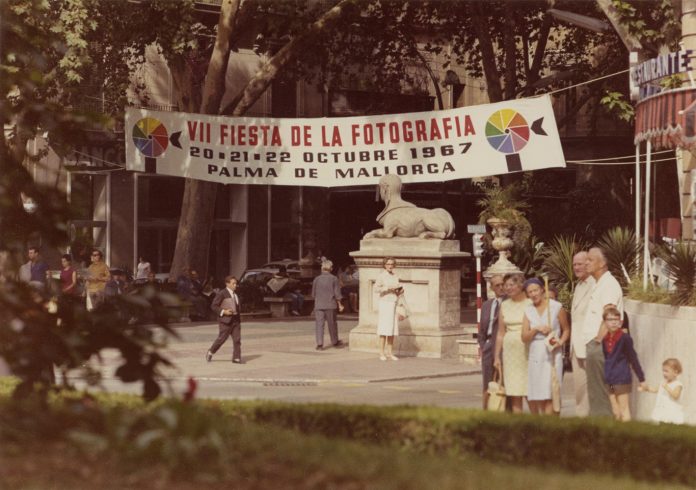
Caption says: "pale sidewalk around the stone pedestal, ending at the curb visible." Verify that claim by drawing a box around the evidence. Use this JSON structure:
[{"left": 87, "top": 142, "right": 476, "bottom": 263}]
[{"left": 122, "top": 315, "right": 480, "bottom": 384}]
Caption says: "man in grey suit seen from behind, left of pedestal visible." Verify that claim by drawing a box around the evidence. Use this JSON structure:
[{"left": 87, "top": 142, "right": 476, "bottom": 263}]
[{"left": 312, "top": 260, "right": 343, "bottom": 350}]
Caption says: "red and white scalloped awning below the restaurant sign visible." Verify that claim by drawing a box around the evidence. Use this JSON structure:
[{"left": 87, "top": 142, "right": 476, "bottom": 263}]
[{"left": 634, "top": 87, "right": 696, "bottom": 150}]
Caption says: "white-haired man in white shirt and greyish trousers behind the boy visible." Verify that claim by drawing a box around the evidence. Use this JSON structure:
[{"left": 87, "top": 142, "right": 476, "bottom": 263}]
[{"left": 582, "top": 247, "right": 623, "bottom": 417}]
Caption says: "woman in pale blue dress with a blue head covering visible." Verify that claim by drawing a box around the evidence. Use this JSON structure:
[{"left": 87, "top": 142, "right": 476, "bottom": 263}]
[{"left": 522, "top": 278, "right": 570, "bottom": 415}]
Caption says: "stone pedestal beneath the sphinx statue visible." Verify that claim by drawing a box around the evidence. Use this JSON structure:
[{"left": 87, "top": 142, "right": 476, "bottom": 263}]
[{"left": 349, "top": 238, "right": 469, "bottom": 358}]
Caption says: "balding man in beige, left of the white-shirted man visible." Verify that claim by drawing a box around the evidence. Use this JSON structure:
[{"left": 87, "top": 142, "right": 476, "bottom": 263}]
[{"left": 570, "top": 252, "right": 595, "bottom": 417}]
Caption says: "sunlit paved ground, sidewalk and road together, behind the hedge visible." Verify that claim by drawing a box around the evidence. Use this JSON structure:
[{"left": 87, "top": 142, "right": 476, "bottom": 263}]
[{"left": 68, "top": 315, "right": 574, "bottom": 416}]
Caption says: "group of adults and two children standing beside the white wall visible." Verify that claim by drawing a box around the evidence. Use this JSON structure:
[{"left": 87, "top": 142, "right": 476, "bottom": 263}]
[{"left": 478, "top": 247, "right": 684, "bottom": 423}]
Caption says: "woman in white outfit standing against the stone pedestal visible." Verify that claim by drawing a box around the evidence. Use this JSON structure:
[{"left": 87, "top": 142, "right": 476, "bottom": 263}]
[{"left": 375, "top": 257, "right": 404, "bottom": 361}]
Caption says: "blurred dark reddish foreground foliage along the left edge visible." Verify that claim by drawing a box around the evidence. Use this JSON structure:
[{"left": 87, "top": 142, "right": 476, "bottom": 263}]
[{"left": 0, "top": 0, "right": 184, "bottom": 402}]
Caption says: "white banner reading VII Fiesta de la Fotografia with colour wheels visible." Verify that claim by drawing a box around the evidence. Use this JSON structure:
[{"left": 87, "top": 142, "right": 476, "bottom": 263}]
[{"left": 126, "top": 96, "right": 565, "bottom": 187}]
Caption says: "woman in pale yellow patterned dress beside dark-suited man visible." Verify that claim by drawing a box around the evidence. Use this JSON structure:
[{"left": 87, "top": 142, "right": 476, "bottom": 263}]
[{"left": 493, "top": 274, "right": 531, "bottom": 413}]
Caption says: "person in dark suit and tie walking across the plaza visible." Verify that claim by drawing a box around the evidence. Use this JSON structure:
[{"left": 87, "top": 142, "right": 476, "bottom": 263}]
[{"left": 205, "top": 276, "right": 242, "bottom": 364}]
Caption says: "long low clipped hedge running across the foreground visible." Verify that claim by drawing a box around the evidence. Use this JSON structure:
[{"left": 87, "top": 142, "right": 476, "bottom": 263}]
[{"left": 0, "top": 383, "right": 696, "bottom": 487}]
